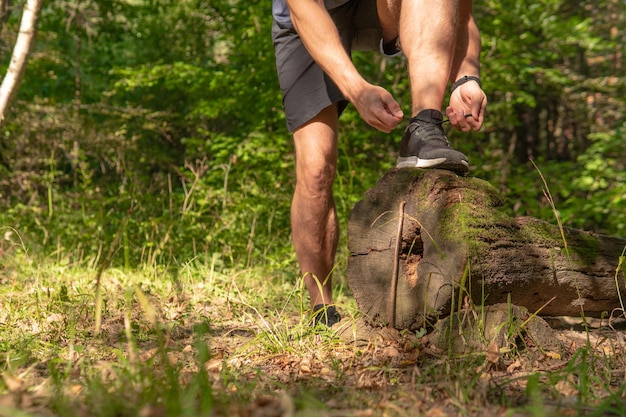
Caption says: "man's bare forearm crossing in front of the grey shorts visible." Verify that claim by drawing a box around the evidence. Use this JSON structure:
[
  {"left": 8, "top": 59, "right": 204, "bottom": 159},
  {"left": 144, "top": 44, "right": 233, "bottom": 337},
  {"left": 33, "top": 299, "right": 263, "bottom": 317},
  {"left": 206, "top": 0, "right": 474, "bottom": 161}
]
[{"left": 287, "top": 0, "right": 365, "bottom": 101}]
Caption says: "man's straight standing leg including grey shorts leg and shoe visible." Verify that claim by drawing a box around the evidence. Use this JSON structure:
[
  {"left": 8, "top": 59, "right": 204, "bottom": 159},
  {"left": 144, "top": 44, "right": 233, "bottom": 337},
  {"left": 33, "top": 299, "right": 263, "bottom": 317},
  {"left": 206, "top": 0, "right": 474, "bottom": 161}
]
[{"left": 272, "top": 14, "right": 351, "bottom": 326}]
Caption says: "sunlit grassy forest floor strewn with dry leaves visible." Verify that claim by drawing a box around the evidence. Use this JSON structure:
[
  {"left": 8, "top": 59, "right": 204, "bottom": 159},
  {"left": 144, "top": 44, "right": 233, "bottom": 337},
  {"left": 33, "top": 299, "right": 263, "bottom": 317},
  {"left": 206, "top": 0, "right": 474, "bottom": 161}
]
[{"left": 0, "top": 252, "right": 626, "bottom": 417}]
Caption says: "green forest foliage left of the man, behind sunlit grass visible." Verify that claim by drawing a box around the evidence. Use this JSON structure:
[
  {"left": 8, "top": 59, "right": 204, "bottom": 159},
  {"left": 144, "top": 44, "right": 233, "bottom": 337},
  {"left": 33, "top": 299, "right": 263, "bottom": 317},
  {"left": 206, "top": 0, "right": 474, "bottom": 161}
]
[{"left": 3, "top": 1, "right": 293, "bottom": 264}]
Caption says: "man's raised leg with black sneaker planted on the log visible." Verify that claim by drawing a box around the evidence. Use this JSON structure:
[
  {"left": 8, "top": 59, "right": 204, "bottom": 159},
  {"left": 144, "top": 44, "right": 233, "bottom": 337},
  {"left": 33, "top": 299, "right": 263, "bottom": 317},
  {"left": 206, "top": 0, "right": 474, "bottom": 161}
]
[{"left": 377, "top": 0, "right": 469, "bottom": 172}]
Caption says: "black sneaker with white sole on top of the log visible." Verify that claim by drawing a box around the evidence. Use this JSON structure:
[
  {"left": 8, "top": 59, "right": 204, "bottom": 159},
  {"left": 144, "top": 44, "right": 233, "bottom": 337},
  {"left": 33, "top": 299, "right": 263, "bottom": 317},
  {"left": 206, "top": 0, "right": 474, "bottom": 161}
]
[{"left": 396, "top": 110, "right": 469, "bottom": 173}]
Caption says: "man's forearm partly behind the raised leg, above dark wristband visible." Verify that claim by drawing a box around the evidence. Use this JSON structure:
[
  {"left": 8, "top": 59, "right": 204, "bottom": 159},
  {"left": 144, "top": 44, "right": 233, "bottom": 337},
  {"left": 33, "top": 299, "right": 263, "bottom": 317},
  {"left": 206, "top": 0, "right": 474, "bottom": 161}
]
[{"left": 450, "top": 0, "right": 481, "bottom": 82}]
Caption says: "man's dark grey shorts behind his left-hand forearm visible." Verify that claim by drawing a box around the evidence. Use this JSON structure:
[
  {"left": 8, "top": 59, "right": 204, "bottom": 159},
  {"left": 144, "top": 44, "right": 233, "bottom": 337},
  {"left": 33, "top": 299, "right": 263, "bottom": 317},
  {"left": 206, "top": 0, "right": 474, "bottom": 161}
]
[{"left": 272, "top": 0, "right": 382, "bottom": 132}]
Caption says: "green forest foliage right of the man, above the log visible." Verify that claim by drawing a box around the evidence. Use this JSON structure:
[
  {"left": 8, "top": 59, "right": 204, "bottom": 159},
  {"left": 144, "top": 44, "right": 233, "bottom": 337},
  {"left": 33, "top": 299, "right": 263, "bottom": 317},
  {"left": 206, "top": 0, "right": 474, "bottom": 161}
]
[{"left": 468, "top": 0, "right": 626, "bottom": 236}]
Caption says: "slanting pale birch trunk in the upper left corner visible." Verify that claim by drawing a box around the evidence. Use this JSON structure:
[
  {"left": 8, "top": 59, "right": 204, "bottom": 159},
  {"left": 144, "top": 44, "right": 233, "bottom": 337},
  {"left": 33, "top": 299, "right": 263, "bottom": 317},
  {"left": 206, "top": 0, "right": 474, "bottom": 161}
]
[{"left": 0, "top": 0, "right": 43, "bottom": 125}]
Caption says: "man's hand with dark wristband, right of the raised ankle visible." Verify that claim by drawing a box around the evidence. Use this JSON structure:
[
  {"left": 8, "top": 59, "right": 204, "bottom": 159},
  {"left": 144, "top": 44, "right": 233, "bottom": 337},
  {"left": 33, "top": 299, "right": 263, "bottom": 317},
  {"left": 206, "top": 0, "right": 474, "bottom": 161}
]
[{"left": 446, "top": 81, "right": 487, "bottom": 132}]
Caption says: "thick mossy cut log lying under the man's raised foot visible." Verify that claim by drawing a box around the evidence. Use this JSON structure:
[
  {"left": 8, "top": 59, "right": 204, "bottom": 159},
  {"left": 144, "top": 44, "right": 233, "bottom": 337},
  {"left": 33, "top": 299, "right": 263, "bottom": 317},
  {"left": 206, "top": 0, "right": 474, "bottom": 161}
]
[{"left": 347, "top": 169, "right": 626, "bottom": 329}]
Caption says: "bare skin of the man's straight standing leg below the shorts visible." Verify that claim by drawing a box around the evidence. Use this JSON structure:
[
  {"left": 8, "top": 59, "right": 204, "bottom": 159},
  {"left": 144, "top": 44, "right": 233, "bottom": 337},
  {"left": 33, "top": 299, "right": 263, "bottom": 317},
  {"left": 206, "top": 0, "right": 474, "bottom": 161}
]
[{"left": 291, "top": 106, "right": 339, "bottom": 306}]
